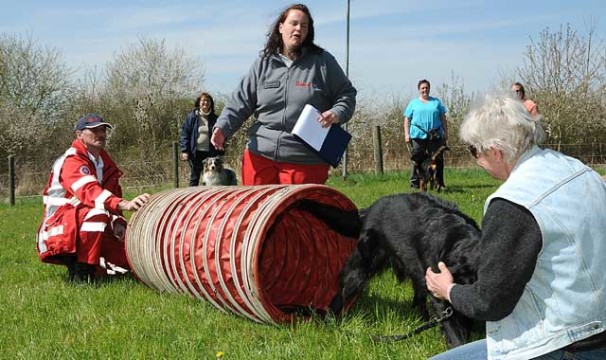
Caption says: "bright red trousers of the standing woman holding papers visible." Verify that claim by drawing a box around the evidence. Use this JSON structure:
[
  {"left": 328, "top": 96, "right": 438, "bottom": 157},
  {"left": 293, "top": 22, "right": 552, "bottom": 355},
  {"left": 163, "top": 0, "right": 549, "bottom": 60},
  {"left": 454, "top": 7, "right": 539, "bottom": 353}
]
[{"left": 242, "top": 149, "right": 330, "bottom": 185}]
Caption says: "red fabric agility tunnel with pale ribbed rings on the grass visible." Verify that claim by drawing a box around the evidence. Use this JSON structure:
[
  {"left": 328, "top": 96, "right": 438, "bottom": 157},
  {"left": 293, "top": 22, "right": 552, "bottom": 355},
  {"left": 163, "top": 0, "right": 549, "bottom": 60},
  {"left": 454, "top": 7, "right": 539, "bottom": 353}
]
[{"left": 126, "top": 185, "right": 357, "bottom": 324}]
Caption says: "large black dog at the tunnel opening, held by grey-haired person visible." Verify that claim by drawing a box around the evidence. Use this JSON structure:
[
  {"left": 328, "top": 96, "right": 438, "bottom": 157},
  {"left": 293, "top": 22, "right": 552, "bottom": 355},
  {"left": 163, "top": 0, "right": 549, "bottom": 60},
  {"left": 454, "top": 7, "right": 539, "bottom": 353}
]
[{"left": 330, "top": 192, "right": 481, "bottom": 348}]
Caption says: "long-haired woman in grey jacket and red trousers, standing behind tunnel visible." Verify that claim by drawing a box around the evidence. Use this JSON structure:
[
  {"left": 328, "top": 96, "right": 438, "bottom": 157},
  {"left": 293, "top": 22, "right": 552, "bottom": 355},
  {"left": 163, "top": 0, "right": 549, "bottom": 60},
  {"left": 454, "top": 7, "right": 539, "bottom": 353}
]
[{"left": 211, "top": 4, "right": 356, "bottom": 185}]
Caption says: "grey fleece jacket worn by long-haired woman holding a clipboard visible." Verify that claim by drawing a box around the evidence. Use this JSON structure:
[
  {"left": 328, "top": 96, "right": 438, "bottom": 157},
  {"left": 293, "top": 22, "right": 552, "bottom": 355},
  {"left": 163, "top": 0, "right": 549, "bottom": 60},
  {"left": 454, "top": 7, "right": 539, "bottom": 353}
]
[{"left": 215, "top": 49, "right": 357, "bottom": 164}]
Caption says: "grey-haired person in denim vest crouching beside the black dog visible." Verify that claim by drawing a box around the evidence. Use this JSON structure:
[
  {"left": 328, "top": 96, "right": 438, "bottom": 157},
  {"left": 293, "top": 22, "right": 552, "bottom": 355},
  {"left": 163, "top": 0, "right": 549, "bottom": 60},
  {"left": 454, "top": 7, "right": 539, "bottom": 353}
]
[{"left": 425, "top": 95, "right": 606, "bottom": 360}]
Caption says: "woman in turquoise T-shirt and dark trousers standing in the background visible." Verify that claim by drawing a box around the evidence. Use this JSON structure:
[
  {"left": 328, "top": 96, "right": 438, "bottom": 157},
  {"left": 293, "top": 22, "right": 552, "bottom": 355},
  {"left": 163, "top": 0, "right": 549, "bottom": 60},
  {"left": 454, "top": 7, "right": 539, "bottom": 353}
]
[{"left": 404, "top": 79, "right": 448, "bottom": 190}]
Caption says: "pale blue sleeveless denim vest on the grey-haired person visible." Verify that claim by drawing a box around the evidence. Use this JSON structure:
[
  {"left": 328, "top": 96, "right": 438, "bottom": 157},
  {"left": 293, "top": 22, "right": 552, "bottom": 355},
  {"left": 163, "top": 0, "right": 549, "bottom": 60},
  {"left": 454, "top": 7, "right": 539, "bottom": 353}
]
[{"left": 484, "top": 146, "right": 606, "bottom": 360}]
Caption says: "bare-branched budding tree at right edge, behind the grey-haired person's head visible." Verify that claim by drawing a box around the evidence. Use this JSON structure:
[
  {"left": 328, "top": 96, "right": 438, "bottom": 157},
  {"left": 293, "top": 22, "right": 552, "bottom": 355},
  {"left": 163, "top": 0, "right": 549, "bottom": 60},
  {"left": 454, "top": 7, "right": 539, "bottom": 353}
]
[{"left": 516, "top": 24, "right": 606, "bottom": 150}]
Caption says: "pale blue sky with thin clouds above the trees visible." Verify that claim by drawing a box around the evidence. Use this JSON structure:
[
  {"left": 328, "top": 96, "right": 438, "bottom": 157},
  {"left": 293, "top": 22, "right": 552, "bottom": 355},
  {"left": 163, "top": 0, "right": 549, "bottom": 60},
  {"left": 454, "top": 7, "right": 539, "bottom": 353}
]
[{"left": 0, "top": 0, "right": 606, "bottom": 100}]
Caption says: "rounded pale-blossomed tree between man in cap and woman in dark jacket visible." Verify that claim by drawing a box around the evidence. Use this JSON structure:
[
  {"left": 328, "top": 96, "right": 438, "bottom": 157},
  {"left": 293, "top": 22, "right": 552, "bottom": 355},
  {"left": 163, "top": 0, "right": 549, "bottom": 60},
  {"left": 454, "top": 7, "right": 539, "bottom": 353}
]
[{"left": 100, "top": 38, "right": 204, "bottom": 156}]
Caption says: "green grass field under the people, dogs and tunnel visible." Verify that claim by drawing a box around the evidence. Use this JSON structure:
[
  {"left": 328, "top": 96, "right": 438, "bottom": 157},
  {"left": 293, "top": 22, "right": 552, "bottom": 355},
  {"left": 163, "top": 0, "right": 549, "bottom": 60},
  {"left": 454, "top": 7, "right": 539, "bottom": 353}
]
[{"left": 0, "top": 169, "right": 498, "bottom": 359}]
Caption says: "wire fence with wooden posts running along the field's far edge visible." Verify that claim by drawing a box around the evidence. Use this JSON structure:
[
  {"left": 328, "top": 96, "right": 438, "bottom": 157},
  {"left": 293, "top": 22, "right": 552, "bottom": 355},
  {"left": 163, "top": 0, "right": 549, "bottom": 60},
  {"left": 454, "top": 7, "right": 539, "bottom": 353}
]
[{"left": 0, "top": 143, "right": 606, "bottom": 203}]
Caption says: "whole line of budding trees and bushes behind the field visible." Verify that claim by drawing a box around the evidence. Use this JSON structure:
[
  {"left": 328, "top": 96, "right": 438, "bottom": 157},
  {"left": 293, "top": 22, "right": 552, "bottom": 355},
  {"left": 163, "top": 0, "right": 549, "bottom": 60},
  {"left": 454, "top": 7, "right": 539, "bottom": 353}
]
[{"left": 0, "top": 25, "right": 606, "bottom": 194}]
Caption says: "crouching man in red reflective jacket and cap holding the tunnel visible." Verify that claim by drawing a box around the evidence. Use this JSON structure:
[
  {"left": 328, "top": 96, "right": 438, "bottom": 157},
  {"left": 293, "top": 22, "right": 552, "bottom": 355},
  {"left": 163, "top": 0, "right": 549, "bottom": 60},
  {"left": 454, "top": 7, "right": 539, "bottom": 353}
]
[{"left": 36, "top": 114, "right": 149, "bottom": 282}]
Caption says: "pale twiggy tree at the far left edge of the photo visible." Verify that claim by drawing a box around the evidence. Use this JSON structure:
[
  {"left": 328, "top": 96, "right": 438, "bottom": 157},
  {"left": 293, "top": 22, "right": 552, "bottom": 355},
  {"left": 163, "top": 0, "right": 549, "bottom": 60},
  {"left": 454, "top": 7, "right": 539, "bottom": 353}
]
[{"left": 0, "top": 33, "right": 73, "bottom": 171}]
